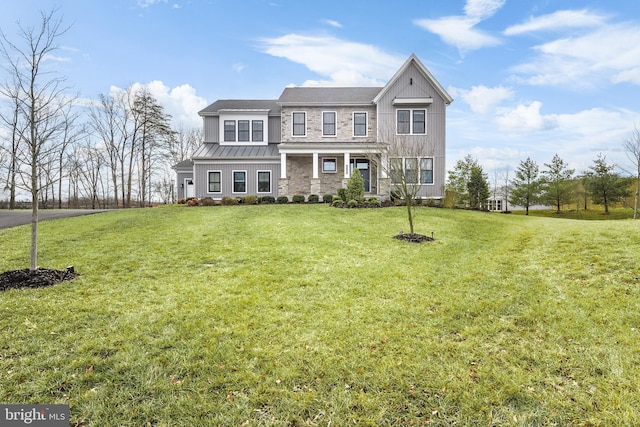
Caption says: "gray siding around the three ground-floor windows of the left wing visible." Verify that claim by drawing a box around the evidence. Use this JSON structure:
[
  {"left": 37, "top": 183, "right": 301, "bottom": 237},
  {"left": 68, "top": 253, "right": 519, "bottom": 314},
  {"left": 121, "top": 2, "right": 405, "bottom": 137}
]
[{"left": 194, "top": 160, "right": 280, "bottom": 199}]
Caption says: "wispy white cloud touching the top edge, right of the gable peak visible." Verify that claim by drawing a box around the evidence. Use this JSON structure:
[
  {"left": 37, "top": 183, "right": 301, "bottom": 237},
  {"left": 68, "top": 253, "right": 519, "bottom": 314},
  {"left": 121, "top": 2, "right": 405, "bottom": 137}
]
[{"left": 414, "top": 0, "right": 506, "bottom": 54}]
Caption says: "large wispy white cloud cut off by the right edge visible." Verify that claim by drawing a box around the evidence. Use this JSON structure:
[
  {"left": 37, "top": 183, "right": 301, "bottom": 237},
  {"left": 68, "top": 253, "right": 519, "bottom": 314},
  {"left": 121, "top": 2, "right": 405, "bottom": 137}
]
[{"left": 512, "top": 24, "right": 640, "bottom": 87}]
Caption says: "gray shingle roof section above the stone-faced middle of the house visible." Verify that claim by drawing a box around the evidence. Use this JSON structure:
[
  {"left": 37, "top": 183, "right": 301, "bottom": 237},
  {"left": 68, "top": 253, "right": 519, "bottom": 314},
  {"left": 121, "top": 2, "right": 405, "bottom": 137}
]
[{"left": 278, "top": 87, "right": 382, "bottom": 105}]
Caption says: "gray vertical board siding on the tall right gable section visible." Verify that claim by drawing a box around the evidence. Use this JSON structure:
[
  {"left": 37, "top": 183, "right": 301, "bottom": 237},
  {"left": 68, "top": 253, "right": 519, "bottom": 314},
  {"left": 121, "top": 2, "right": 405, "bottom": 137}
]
[{"left": 377, "top": 60, "right": 447, "bottom": 197}]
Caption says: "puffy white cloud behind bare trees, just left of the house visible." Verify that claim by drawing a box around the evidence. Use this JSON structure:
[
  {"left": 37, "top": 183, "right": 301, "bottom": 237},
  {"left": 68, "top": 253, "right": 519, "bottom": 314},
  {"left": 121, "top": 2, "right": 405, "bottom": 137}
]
[{"left": 111, "top": 80, "right": 207, "bottom": 129}]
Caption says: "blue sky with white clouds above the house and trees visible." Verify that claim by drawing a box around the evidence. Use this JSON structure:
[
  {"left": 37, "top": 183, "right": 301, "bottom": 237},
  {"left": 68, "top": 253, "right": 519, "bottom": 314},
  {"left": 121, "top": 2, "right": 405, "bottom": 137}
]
[{"left": 0, "top": 0, "right": 640, "bottom": 175}]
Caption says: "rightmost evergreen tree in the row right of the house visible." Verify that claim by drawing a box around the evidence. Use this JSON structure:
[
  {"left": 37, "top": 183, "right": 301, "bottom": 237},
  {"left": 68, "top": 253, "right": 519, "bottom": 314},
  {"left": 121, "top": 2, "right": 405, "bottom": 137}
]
[{"left": 585, "top": 154, "right": 629, "bottom": 214}]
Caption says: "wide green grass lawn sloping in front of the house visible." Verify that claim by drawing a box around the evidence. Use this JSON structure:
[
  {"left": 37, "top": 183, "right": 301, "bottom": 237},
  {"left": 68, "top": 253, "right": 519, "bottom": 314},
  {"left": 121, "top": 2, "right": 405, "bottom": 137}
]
[{"left": 0, "top": 205, "right": 640, "bottom": 426}]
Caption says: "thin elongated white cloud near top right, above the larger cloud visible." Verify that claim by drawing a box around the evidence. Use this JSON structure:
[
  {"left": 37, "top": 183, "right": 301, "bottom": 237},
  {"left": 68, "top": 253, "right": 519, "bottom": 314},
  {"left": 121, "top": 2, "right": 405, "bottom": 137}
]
[{"left": 504, "top": 9, "right": 606, "bottom": 36}]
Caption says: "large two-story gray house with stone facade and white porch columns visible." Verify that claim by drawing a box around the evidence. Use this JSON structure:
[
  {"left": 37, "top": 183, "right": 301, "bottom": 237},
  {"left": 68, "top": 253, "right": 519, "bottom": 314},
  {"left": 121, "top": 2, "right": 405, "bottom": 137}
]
[{"left": 176, "top": 55, "right": 453, "bottom": 199}]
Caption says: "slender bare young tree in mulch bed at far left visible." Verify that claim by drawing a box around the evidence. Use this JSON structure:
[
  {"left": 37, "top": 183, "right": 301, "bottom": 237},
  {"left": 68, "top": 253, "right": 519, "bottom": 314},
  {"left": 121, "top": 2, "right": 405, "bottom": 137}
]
[{"left": 0, "top": 9, "right": 73, "bottom": 271}]
